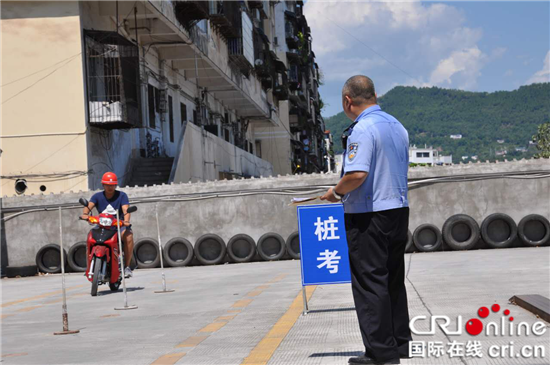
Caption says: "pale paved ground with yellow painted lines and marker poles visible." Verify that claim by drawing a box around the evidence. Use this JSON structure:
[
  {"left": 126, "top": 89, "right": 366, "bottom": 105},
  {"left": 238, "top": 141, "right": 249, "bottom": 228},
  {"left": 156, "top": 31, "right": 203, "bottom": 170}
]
[{"left": 0, "top": 248, "right": 550, "bottom": 365}]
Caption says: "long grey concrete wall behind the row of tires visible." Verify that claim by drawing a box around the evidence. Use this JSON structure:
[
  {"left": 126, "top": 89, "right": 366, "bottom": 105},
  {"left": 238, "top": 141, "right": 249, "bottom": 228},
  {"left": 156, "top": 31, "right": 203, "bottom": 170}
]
[{"left": 1, "top": 160, "right": 550, "bottom": 267}]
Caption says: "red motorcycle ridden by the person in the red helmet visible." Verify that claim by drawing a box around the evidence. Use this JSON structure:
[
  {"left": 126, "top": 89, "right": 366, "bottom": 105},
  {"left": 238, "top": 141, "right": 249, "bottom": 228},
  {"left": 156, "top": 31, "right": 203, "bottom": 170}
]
[{"left": 79, "top": 198, "right": 137, "bottom": 297}]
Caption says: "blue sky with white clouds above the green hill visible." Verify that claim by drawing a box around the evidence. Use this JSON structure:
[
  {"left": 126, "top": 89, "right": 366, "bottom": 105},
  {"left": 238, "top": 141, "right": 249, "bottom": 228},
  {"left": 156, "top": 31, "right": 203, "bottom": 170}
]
[{"left": 305, "top": 0, "right": 550, "bottom": 117}]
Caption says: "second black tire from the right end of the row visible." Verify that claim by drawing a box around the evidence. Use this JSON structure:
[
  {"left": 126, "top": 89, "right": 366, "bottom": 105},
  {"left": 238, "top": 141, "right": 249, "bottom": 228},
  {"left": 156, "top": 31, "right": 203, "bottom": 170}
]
[{"left": 481, "top": 213, "right": 518, "bottom": 248}]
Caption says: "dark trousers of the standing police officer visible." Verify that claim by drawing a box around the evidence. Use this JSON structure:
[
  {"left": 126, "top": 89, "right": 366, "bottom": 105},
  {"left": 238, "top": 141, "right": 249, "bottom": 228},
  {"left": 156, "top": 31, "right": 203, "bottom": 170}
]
[{"left": 345, "top": 208, "right": 412, "bottom": 361}]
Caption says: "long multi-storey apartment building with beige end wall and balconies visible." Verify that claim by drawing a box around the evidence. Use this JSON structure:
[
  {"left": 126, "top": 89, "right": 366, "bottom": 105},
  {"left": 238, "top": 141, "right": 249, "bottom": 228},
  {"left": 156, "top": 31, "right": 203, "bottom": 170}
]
[{"left": 0, "top": 1, "right": 326, "bottom": 194}]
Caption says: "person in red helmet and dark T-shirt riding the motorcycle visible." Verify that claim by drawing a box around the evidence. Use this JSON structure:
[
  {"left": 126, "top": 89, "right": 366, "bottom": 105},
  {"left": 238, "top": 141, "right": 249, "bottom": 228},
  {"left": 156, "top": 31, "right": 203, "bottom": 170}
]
[{"left": 81, "top": 172, "right": 134, "bottom": 278}]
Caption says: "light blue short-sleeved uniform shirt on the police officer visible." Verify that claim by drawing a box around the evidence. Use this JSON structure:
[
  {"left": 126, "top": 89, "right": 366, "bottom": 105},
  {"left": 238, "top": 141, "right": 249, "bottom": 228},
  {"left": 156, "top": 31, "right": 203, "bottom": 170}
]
[{"left": 342, "top": 105, "right": 409, "bottom": 213}]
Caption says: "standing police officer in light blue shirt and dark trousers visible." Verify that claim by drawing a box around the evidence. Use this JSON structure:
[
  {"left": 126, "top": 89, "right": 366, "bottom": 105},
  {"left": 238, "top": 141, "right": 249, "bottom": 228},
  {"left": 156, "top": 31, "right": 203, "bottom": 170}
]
[{"left": 321, "top": 75, "right": 412, "bottom": 364}]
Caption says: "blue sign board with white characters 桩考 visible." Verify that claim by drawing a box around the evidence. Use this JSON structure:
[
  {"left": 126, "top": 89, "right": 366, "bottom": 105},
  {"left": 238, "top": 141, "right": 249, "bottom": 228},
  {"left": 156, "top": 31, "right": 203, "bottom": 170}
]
[{"left": 298, "top": 204, "right": 351, "bottom": 286}]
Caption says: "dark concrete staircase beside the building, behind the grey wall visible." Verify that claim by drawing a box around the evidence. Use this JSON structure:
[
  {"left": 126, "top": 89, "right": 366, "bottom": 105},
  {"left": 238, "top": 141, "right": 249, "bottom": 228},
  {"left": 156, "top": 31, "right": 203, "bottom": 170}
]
[{"left": 128, "top": 157, "right": 174, "bottom": 186}]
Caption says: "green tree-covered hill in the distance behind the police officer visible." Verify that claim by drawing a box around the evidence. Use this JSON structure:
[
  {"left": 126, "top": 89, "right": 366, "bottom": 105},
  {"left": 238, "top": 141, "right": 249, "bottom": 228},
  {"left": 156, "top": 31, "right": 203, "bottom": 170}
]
[{"left": 325, "top": 83, "right": 550, "bottom": 163}]
